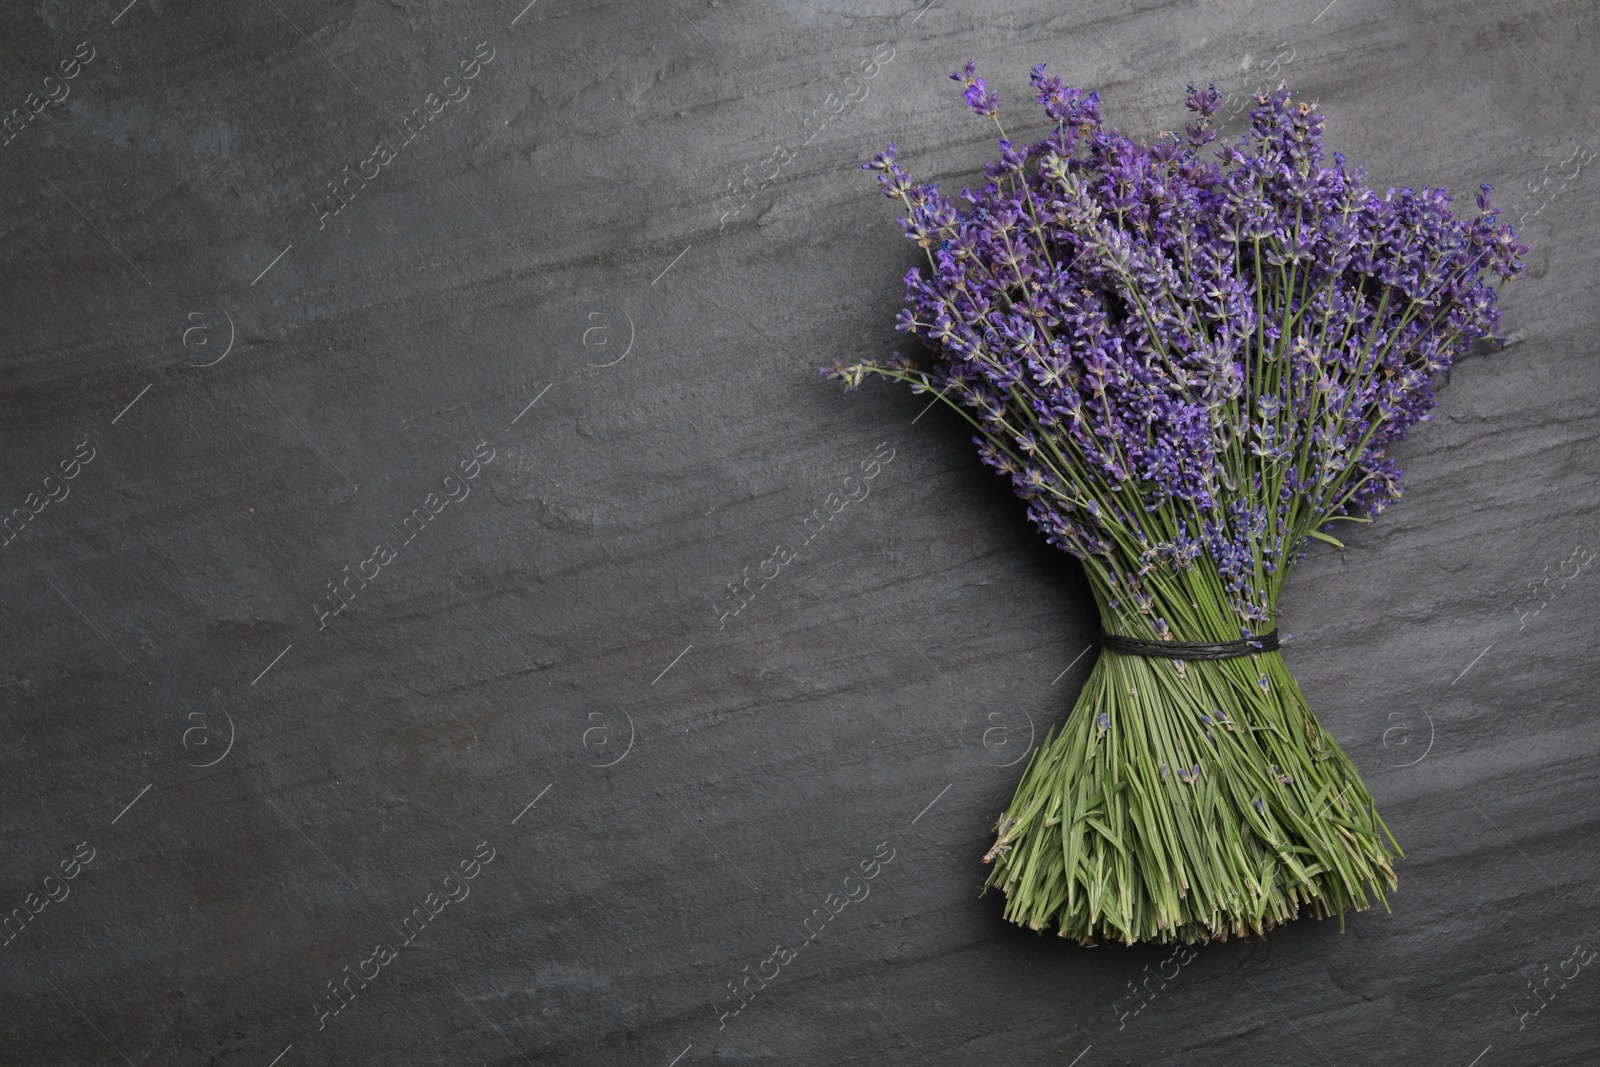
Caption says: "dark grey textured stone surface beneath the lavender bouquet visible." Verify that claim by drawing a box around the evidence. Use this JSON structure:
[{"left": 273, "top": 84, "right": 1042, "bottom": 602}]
[{"left": 0, "top": 0, "right": 1600, "bottom": 1067}]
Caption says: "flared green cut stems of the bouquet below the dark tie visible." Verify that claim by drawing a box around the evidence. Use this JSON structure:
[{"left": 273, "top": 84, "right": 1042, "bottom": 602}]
[{"left": 984, "top": 568, "right": 1400, "bottom": 944}]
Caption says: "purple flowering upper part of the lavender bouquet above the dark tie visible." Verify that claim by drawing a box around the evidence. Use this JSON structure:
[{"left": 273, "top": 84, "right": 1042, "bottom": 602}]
[{"left": 822, "top": 62, "right": 1526, "bottom": 640}]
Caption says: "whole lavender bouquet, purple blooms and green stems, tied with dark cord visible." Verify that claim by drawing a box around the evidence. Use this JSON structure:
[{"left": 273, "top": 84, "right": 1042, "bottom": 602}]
[{"left": 822, "top": 70, "right": 1528, "bottom": 944}]
